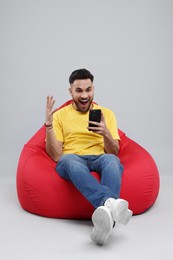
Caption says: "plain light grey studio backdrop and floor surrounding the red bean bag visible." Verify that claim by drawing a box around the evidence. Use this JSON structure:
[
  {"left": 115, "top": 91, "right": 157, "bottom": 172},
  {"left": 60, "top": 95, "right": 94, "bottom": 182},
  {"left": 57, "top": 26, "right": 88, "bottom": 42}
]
[{"left": 0, "top": 0, "right": 173, "bottom": 259}]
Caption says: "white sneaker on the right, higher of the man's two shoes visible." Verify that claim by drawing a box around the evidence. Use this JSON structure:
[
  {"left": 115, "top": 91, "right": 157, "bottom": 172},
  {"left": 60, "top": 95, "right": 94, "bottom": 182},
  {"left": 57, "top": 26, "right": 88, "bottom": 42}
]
[{"left": 104, "top": 198, "right": 133, "bottom": 225}]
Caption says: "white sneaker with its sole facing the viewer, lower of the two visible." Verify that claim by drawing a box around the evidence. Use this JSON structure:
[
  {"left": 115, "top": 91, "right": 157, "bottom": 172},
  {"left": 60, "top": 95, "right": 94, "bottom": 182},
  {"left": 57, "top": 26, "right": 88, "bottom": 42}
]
[{"left": 90, "top": 206, "right": 114, "bottom": 245}]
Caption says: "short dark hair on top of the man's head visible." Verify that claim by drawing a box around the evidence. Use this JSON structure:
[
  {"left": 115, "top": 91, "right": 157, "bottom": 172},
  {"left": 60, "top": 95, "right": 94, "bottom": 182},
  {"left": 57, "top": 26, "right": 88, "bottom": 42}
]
[{"left": 69, "top": 69, "right": 94, "bottom": 84}]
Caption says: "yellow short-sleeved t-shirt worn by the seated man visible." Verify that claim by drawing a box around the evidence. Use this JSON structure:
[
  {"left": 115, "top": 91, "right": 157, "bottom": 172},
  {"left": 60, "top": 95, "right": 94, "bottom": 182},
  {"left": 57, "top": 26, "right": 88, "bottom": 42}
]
[{"left": 53, "top": 104, "right": 120, "bottom": 155}]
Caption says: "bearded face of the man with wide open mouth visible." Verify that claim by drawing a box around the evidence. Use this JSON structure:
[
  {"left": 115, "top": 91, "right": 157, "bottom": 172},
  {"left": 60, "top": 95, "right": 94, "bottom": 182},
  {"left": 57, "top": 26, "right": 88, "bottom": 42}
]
[{"left": 69, "top": 79, "right": 94, "bottom": 113}]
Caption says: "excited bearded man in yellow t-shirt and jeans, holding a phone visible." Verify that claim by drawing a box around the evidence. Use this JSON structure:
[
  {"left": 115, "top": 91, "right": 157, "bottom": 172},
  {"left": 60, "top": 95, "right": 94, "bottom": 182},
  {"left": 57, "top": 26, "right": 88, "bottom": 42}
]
[{"left": 45, "top": 69, "right": 132, "bottom": 245}]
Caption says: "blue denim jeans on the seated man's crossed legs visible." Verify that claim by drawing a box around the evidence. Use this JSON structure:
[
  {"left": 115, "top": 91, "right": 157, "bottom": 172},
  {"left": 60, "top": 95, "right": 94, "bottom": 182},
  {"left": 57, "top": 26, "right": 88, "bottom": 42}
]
[{"left": 56, "top": 154, "right": 123, "bottom": 208}]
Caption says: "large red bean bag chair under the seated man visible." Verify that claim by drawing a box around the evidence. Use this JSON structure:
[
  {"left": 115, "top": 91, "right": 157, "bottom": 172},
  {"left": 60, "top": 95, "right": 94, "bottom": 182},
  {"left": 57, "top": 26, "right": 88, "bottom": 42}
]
[{"left": 16, "top": 101, "right": 159, "bottom": 219}]
